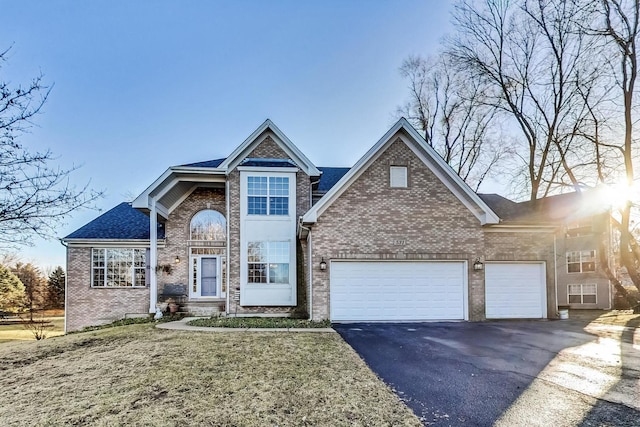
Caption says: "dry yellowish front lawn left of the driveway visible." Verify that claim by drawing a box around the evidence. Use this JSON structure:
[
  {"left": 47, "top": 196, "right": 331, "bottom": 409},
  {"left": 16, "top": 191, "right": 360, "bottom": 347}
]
[{"left": 0, "top": 324, "right": 420, "bottom": 426}]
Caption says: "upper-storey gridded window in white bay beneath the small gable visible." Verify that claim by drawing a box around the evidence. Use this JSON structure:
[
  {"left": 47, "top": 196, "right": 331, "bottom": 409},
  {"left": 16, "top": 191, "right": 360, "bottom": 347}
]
[{"left": 247, "top": 176, "right": 289, "bottom": 215}]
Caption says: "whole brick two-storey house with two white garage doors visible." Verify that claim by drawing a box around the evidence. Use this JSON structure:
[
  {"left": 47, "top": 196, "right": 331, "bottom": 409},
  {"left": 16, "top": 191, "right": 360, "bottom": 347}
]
[{"left": 63, "top": 119, "right": 568, "bottom": 331}]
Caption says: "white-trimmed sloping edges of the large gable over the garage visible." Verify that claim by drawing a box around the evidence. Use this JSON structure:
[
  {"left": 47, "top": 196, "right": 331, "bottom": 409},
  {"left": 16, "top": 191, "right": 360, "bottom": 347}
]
[{"left": 302, "top": 117, "right": 500, "bottom": 225}]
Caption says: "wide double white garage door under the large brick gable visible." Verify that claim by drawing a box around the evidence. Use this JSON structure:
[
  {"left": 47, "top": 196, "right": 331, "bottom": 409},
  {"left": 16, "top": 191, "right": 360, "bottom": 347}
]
[{"left": 330, "top": 261, "right": 467, "bottom": 321}]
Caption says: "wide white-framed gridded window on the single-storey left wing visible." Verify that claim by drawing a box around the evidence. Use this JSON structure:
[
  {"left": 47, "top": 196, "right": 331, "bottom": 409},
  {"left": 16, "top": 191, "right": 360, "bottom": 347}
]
[{"left": 91, "top": 249, "right": 146, "bottom": 288}]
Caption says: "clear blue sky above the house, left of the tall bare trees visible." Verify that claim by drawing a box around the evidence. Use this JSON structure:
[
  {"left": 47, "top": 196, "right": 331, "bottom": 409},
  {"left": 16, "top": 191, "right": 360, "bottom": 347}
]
[{"left": 0, "top": 0, "right": 460, "bottom": 267}]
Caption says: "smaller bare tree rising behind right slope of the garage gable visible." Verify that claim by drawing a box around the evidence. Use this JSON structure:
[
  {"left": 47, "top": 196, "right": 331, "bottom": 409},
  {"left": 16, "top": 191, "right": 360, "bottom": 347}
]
[{"left": 398, "top": 54, "right": 508, "bottom": 191}]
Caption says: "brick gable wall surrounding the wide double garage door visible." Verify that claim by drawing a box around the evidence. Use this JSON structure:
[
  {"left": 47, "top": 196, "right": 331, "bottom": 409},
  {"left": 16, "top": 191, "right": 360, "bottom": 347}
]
[{"left": 311, "top": 138, "right": 484, "bottom": 320}]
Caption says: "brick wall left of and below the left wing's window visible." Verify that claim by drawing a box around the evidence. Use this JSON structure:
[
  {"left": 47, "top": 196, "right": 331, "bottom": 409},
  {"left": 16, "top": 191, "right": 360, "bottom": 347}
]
[{"left": 65, "top": 244, "right": 149, "bottom": 332}]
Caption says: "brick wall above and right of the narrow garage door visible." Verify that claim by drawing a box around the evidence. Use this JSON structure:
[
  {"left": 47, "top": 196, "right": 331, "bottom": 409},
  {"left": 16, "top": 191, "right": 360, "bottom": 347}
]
[{"left": 484, "top": 231, "right": 557, "bottom": 318}]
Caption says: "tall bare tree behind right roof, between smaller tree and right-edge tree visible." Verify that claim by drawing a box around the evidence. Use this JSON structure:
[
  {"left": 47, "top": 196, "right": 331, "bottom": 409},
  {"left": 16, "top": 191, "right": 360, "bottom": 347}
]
[{"left": 448, "top": 0, "right": 598, "bottom": 200}]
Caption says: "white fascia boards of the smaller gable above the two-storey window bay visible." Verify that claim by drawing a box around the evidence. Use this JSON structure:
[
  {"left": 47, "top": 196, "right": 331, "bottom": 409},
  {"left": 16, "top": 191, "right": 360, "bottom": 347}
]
[{"left": 218, "top": 119, "right": 320, "bottom": 176}]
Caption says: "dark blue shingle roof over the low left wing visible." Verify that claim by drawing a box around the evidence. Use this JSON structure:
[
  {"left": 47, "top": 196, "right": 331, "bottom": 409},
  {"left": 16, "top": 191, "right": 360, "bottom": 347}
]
[{"left": 64, "top": 202, "right": 164, "bottom": 240}]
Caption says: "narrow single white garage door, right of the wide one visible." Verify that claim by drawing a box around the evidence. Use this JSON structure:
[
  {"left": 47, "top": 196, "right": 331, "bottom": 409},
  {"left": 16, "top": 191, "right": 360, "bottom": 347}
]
[{"left": 485, "top": 263, "right": 547, "bottom": 319}]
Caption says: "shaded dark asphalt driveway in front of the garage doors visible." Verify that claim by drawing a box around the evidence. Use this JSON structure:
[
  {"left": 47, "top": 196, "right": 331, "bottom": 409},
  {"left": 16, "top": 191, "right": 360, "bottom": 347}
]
[{"left": 334, "top": 316, "right": 639, "bottom": 426}]
